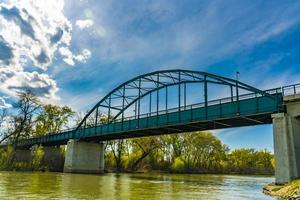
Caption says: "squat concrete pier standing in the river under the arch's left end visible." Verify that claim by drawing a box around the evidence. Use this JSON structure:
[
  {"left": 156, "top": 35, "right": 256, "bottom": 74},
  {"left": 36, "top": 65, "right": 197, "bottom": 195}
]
[{"left": 64, "top": 140, "right": 104, "bottom": 174}]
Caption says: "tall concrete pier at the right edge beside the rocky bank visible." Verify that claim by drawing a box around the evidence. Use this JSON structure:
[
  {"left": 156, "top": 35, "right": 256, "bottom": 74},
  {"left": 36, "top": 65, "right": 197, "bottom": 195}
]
[{"left": 272, "top": 95, "right": 300, "bottom": 184}]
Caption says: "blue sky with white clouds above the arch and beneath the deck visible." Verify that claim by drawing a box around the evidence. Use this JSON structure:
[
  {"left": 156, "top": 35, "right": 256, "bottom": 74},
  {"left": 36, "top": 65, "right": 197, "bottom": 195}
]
[{"left": 0, "top": 0, "right": 300, "bottom": 151}]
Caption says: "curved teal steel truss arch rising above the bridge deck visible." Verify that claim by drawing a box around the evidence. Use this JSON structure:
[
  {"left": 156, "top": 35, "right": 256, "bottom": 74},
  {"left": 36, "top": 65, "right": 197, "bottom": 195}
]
[{"left": 76, "top": 69, "right": 274, "bottom": 130}]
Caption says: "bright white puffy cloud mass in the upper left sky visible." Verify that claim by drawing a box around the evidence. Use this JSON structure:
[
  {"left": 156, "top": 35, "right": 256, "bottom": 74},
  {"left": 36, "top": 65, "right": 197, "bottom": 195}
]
[{"left": 0, "top": 0, "right": 91, "bottom": 105}]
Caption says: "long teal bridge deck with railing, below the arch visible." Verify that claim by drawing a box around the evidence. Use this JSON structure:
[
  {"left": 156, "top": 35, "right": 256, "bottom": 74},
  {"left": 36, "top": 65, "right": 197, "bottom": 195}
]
[{"left": 18, "top": 93, "right": 284, "bottom": 146}]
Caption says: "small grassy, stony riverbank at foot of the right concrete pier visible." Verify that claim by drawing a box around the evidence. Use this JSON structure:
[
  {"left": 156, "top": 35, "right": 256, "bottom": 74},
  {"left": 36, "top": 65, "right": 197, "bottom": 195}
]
[{"left": 263, "top": 179, "right": 300, "bottom": 200}]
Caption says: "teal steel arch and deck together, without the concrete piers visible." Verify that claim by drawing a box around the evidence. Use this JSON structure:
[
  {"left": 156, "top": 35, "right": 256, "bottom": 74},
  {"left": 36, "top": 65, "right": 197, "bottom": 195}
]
[{"left": 18, "top": 69, "right": 284, "bottom": 146}]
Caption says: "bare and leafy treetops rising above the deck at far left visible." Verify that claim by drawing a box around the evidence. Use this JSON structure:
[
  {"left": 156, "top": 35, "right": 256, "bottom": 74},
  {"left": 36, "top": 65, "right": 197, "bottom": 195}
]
[{"left": 0, "top": 91, "right": 74, "bottom": 145}]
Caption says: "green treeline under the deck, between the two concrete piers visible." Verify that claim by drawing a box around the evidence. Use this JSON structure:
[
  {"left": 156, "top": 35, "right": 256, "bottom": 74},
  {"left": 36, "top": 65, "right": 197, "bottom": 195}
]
[{"left": 105, "top": 132, "right": 274, "bottom": 174}]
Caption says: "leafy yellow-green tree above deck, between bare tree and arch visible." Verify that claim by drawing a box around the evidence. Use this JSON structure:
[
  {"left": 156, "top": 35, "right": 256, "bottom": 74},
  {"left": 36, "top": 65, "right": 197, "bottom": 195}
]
[{"left": 35, "top": 104, "right": 74, "bottom": 135}]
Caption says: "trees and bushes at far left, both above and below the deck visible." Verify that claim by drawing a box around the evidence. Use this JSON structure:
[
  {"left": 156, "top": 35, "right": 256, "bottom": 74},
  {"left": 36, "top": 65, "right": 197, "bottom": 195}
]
[{"left": 0, "top": 91, "right": 70, "bottom": 170}]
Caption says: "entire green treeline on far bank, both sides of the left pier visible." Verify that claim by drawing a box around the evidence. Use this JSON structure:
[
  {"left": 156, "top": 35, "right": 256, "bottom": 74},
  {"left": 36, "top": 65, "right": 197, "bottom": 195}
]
[{"left": 0, "top": 92, "right": 274, "bottom": 174}]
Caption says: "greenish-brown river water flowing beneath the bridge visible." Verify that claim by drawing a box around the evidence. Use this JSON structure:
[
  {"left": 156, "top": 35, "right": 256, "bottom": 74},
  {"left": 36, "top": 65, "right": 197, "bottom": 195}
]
[{"left": 0, "top": 172, "right": 274, "bottom": 200}]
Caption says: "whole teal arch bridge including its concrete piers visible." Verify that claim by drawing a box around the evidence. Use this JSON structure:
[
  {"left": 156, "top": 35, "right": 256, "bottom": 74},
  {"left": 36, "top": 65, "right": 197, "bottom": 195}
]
[{"left": 5, "top": 69, "right": 300, "bottom": 183}]
